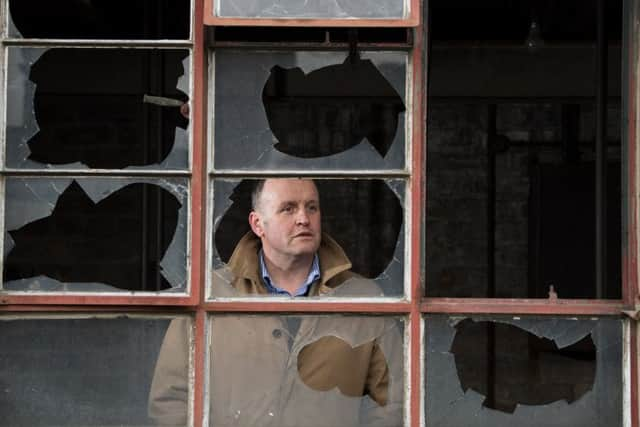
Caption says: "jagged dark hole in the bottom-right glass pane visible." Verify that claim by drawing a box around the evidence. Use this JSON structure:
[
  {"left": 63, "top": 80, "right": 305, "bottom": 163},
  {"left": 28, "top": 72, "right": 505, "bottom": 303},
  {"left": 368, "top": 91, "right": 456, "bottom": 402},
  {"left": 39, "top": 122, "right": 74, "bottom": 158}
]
[{"left": 451, "top": 319, "right": 596, "bottom": 413}]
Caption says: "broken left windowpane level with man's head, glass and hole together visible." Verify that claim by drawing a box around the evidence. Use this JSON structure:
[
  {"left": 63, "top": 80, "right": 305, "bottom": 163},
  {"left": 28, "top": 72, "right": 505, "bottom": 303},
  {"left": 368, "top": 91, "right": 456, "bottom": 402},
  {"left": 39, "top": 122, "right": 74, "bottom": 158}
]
[{"left": 2, "top": 177, "right": 188, "bottom": 292}]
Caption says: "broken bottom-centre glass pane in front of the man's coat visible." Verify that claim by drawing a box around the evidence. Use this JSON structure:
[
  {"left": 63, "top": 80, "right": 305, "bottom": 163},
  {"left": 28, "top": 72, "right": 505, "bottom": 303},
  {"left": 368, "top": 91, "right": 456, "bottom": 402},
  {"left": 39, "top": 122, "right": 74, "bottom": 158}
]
[{"left": 188, "top": 315, "right": 404, "bottom": 427}]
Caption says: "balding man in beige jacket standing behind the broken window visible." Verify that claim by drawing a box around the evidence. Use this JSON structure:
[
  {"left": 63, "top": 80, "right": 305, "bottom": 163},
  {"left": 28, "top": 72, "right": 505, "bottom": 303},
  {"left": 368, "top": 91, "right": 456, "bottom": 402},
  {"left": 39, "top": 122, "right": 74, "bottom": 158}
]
[{"left": 149, "top": 179, "right": 403, "bottom": 427}]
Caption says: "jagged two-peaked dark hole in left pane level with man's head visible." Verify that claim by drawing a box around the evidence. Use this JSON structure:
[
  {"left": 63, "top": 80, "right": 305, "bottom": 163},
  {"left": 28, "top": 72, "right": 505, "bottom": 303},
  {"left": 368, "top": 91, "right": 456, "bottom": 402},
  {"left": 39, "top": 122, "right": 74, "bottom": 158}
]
[{"left": 3, "top": 181, "right": 181, "bottom": 291}]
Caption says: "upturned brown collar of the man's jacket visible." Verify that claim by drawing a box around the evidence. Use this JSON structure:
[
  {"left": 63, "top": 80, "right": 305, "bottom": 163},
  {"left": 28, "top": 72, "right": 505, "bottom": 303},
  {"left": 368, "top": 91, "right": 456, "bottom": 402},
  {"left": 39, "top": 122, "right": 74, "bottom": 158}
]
[{"left": 227, "top": 231, "right": 351, "bottom": 295}]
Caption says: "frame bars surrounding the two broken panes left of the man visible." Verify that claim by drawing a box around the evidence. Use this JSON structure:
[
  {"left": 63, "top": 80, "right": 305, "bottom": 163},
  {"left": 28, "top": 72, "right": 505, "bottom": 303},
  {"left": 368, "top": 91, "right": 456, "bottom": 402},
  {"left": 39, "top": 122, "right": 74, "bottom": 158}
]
[{"left": 0, "top": 0, "right": 204, "bottom": 311}]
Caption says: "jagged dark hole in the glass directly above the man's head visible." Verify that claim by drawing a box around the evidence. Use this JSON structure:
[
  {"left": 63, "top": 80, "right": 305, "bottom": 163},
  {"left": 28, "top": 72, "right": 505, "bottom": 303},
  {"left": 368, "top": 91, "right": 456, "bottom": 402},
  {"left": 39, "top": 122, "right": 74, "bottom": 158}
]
[{"left": 262, "top": 55, "right": 405, "bottom": 158}]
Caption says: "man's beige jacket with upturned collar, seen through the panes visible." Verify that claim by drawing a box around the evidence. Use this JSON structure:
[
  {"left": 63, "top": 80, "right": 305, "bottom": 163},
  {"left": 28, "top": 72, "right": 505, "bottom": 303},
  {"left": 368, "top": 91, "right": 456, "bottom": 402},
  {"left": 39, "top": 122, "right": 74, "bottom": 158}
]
[{"left": 149, "top": 234, "right": 403, "bottom": 427}]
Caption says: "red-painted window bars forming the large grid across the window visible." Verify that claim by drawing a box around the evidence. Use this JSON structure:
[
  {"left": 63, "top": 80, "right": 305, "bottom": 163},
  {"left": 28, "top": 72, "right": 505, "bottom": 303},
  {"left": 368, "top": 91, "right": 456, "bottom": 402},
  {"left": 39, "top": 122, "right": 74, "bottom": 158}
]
[{"left": 0, "top": 0, "right": 640, "bottom": 427}]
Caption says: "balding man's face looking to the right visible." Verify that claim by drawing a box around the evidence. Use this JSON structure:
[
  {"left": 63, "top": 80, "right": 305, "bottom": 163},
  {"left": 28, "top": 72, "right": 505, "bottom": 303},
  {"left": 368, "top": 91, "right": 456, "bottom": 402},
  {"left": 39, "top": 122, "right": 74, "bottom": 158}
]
[{"left": 249, "top": 179, "right": 321, "bottom": 261}]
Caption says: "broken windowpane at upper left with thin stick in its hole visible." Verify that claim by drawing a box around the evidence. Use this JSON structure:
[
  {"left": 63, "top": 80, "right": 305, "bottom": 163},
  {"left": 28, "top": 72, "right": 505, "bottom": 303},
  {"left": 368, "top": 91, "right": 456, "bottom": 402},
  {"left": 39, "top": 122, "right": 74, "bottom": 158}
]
[{"left": 6, "top": 47, "right": 190, "bottom": 169}]
